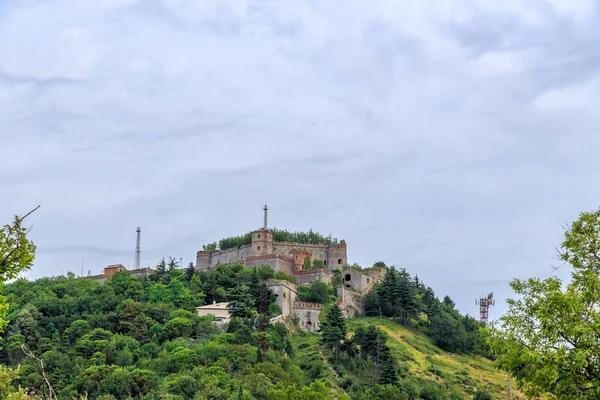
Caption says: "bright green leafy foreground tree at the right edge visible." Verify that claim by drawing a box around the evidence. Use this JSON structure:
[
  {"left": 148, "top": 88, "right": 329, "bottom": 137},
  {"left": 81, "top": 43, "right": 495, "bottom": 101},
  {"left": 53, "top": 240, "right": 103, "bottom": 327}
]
[{"left": 486, "top": 210, "right": 600, "bottom": 399}]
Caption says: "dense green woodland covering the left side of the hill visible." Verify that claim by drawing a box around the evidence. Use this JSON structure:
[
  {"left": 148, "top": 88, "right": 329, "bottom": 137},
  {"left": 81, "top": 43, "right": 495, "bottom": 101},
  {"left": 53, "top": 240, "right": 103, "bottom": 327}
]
[{"left": 0, "top": 260, "right": 318, "bottom": 400}]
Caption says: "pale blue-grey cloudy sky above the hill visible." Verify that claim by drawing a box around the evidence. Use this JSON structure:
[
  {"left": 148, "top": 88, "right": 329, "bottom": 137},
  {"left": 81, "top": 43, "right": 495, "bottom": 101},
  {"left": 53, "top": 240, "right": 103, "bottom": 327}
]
[{"left": 0, "top": 0, "right": 600, "bottom": 319}]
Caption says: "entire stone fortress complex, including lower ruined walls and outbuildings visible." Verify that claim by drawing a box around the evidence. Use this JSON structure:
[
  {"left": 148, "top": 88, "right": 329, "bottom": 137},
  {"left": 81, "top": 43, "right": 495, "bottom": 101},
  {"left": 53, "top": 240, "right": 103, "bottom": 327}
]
[{"left": 92, "top": 205, "right": 386, "bottom": 332}]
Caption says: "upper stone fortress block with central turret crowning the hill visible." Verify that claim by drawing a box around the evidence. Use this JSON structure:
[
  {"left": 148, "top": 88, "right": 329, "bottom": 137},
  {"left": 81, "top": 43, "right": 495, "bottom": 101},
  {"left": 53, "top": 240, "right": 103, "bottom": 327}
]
[{"left": 196, "top": 206, "right": 348, "bottom": 275}]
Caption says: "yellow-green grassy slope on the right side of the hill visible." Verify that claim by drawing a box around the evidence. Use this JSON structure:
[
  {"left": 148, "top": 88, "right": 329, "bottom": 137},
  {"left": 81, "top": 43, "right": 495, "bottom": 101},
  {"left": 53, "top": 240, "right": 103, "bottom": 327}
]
[{"left": 348, "top": 317, "right": 524, "bottom": 399}]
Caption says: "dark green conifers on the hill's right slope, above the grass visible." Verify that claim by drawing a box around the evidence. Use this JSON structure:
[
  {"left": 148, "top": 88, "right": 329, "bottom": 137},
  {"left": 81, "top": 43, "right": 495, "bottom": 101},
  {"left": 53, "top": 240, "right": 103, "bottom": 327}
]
[{"left": 365, "top": 267, "right": 489, "bottom": 356}]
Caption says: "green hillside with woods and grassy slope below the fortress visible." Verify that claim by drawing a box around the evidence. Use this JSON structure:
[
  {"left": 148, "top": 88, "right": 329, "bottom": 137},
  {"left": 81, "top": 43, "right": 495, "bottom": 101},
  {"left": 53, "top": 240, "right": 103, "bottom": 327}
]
[{"left": 0, "top": 265, "right": 507, "bottom": 400}]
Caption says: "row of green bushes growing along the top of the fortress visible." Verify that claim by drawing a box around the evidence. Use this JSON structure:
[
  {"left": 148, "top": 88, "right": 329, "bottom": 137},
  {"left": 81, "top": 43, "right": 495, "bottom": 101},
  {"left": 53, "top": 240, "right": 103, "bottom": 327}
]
[{"left": 202, "top": 228, "right": 337, "bottom": 251}]
